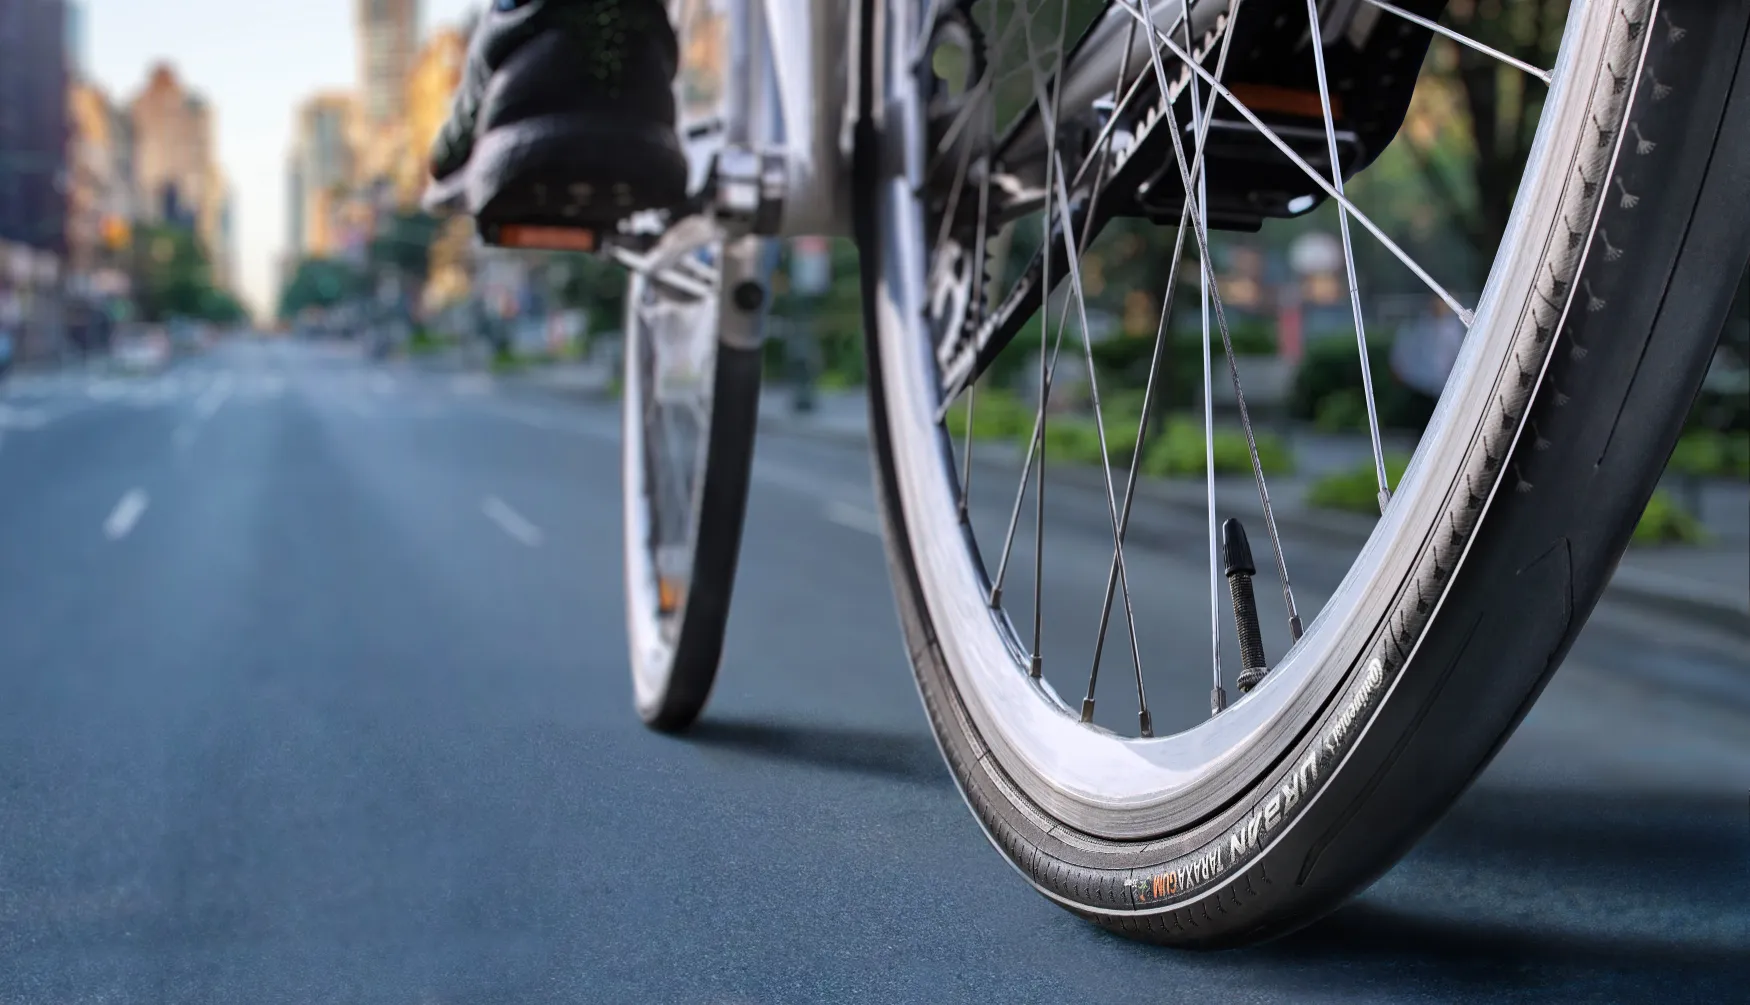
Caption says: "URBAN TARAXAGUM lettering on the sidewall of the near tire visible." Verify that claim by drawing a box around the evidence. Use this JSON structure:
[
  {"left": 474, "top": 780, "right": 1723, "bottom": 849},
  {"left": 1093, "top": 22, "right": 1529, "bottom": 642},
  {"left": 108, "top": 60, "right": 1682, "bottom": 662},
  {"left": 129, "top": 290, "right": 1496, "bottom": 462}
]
[{"left": 1127, "top": 658, "right": 1388, "bottom": 907}]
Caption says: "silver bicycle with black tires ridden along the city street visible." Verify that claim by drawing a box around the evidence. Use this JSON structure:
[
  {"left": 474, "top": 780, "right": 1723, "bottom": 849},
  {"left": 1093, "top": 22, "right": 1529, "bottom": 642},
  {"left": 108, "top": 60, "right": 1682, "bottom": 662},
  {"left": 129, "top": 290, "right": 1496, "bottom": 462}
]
[{"left": 511, "top": 0, "right": 1750, "bottom": 947}]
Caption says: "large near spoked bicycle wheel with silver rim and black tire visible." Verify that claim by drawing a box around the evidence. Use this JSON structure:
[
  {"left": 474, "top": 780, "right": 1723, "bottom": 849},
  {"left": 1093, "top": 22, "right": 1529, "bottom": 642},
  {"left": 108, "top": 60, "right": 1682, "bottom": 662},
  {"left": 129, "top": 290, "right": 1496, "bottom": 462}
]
[{"left": 858, "top": 0, "right": 1750, "bottom": 947}]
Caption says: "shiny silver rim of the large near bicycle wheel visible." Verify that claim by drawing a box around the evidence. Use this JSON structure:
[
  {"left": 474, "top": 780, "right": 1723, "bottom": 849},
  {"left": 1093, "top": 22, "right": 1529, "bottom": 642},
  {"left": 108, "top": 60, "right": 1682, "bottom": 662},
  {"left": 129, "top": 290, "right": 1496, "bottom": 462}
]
[{"left": 873, "top": 0, "right": 1645, "bottom": 839}]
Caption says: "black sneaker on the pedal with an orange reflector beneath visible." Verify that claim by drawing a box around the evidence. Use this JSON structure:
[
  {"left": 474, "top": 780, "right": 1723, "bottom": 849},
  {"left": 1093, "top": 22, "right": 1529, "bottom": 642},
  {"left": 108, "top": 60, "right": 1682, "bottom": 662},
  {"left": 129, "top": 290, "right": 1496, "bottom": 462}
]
[{"left": 424, "top": 0, "right": 688, "bottom": 250}]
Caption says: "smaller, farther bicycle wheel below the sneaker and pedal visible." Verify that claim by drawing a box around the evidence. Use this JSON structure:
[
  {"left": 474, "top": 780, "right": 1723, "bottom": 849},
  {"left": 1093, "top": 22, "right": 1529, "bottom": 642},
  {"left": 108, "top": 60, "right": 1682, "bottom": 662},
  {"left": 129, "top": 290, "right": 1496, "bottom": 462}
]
[{"left": 621, "top": 240, "right": 763, "bottom": 730}]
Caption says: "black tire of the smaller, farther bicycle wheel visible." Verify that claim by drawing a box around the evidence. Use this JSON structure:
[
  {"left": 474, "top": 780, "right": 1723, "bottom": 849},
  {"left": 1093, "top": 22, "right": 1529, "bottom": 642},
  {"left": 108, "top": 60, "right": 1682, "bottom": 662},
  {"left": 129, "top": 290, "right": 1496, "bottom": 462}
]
[{"left": 621, "top": 242, "right": 765, "bottom": 732}]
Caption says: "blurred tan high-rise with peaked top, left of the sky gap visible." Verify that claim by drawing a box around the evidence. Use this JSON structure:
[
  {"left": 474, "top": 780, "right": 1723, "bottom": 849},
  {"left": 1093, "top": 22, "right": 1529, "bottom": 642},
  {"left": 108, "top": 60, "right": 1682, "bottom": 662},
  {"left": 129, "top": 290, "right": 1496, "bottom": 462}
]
[{"left": 130, "top": 63, "right": 233, "bottom": 289}]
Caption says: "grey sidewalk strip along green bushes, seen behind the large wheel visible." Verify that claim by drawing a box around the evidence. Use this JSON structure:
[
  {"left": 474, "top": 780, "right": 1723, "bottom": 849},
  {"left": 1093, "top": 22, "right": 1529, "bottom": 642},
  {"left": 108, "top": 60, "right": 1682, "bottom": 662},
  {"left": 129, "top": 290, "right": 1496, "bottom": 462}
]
[{"left": 760, "top": 387, "right": 1750, "bottom": 637}]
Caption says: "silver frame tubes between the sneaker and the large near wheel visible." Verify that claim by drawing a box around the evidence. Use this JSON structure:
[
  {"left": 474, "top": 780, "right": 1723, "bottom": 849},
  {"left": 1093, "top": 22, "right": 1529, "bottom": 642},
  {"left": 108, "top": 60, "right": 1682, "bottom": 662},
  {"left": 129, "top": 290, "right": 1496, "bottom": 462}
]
[{"left": 669, "top": 0, "right": 863, "bottom": 236}]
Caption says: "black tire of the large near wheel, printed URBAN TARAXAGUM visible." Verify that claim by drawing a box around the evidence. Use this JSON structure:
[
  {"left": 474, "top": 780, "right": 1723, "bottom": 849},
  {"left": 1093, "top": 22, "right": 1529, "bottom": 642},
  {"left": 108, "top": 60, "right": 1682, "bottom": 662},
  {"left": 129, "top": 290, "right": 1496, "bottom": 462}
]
[{"left": 856, "top": 0, "right": 1750, "bottom": 947}]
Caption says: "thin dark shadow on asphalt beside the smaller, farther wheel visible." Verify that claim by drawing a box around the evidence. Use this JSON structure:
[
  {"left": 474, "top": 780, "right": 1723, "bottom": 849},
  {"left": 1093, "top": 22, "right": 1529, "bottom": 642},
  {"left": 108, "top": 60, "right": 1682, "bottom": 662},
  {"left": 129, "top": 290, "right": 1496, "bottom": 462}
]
[{"left": 686, "top": 720, "right": 954, "bottom": 788}]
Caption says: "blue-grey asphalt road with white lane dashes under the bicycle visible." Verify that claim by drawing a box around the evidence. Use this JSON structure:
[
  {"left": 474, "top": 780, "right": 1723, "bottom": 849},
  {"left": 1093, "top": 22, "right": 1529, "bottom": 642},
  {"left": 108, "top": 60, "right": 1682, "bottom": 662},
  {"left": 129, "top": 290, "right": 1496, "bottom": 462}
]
[{"left": 0, "top": 343, "right": 1750, "bottom": 1003}]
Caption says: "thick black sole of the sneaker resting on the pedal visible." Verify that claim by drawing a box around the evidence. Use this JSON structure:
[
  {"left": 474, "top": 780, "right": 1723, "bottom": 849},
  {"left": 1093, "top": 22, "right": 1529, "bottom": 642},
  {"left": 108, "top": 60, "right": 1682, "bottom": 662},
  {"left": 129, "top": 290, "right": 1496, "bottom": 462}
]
[{"left": 462, "top": 114, "right": 688, "bottom": 231}]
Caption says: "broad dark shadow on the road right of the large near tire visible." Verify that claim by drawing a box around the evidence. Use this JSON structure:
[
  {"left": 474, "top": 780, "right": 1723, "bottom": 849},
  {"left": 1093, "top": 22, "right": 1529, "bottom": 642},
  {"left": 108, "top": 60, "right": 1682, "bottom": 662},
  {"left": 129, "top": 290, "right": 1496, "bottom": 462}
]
[{"left": 1230, "top": 790, "right": 1750, "bottom": 1001}]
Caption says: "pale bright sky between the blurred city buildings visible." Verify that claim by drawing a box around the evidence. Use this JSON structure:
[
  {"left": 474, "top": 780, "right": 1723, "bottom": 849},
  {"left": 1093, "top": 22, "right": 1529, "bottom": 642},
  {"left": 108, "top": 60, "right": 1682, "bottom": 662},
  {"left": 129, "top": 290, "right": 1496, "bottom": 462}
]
[{"left": 75, "top": 0, "right": 478, "bottom": 317}]
